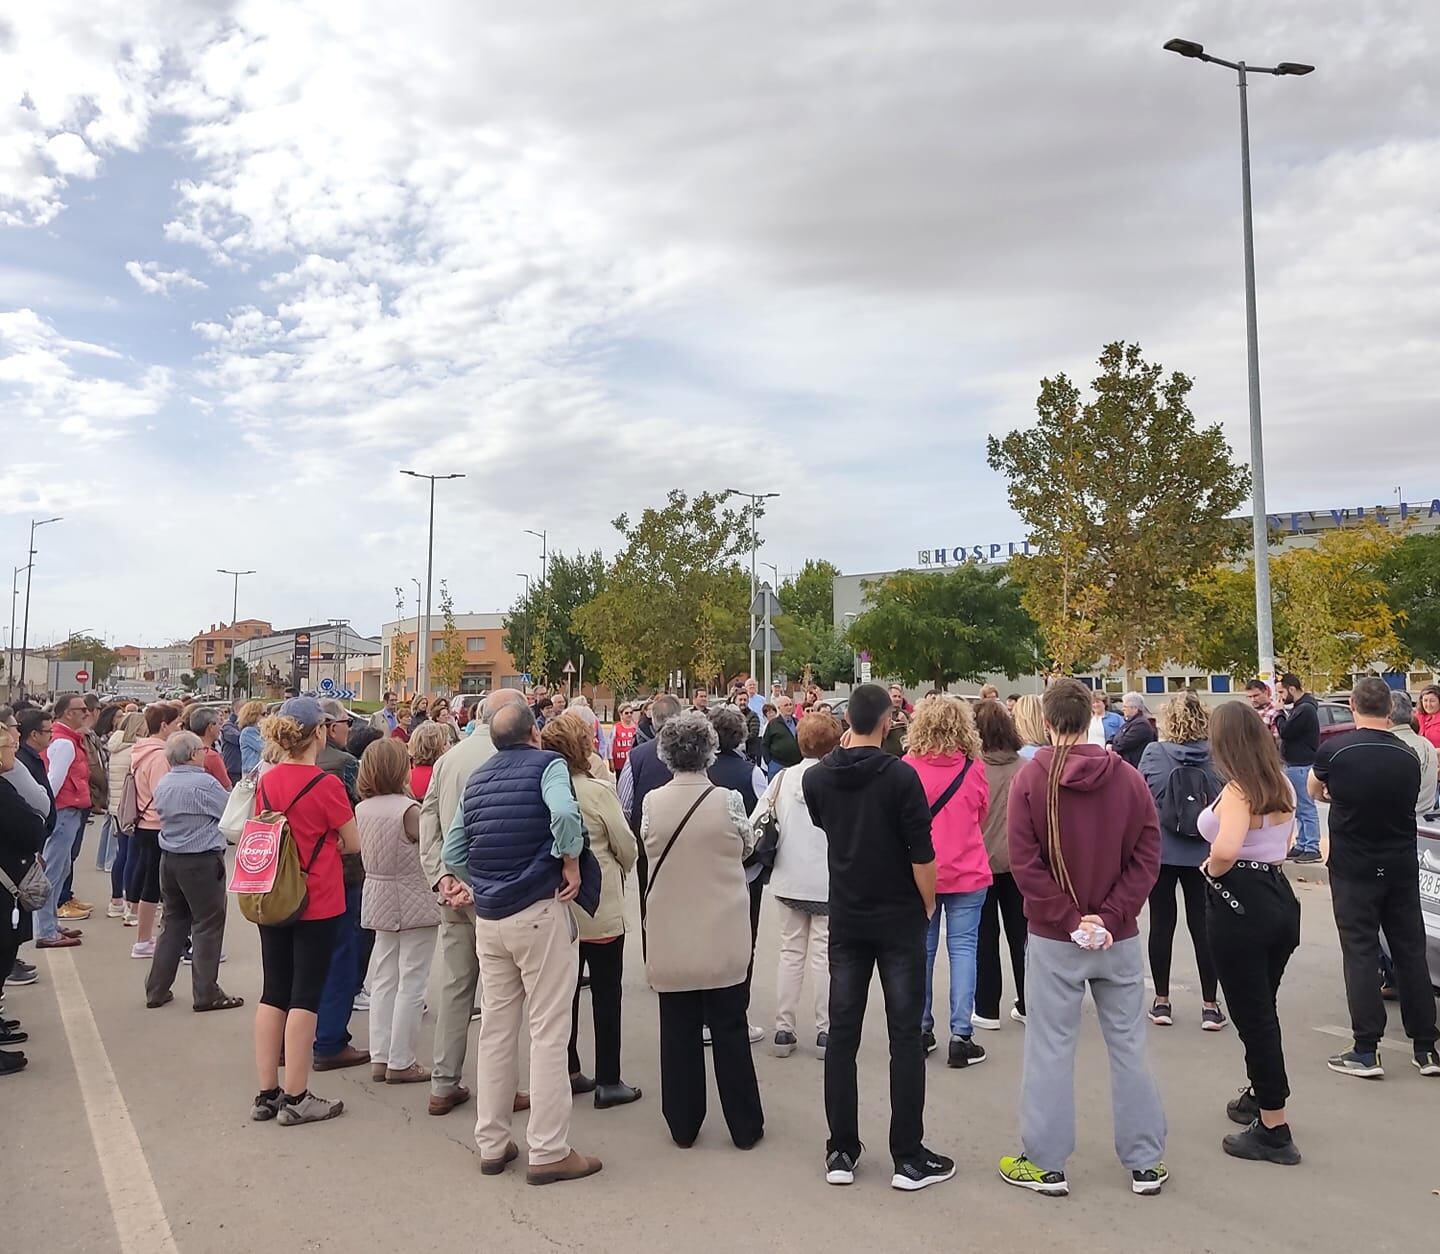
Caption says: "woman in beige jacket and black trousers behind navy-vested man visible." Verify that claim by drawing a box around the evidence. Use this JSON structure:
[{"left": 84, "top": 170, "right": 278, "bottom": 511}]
[{"left": 540, "top": 711, "right": 641, "bottom": 1110}]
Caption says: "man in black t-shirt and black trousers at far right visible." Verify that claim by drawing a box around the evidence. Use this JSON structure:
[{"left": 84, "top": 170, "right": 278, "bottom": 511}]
[{"left": 1309, "top": 678, "right": 1440, "bottom": 1077}]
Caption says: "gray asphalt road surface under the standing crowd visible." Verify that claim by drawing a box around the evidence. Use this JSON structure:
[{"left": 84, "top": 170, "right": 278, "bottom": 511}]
[{"left": 0, "top": 839, "right": 1440, "bottom": 1254}]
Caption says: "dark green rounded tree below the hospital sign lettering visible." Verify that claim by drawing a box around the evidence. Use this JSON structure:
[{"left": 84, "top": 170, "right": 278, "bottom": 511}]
[{"left": 847, "top": 563, "right": 1037, "bottom": 688}]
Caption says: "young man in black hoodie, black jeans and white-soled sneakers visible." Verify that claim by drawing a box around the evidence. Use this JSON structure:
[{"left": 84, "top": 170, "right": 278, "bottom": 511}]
[{"left": 802, "top": 684, "right": 955, "bottom": 1191}]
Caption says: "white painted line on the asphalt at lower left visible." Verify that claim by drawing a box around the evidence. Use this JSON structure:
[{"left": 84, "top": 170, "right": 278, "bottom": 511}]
[{"left": 48, "top": 949, "right": 179, "bottom": 1254}]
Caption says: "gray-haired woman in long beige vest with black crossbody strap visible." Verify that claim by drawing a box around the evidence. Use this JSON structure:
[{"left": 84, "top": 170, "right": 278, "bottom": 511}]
[{"left": 639, "top": 711, "right": 765, "bottom": 1149}]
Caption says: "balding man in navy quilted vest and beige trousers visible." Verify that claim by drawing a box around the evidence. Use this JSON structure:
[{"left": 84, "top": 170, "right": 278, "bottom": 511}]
[{"left": 441, "top": 705, "right": 600, "bottom": 1185}]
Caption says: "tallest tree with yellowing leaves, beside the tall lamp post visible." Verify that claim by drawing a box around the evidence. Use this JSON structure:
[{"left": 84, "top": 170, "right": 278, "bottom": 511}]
[{"left": 988, "top": 343, "right": 1250, "bottom": 682}]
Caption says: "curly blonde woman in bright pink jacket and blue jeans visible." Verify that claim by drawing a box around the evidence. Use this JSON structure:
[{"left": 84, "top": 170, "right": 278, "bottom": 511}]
[{"left": 904, "top": 695, "right": 994, "bottom": 1067}]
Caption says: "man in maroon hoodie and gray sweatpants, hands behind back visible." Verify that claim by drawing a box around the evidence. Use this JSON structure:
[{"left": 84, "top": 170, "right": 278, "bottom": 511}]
[{"left": 999, "top": 680, "right": 1168, "bottom": 1195}]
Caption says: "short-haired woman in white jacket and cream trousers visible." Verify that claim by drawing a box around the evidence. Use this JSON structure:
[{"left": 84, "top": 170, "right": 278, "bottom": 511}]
[{"left": 750, "top": 714, "right": 841, "bottom": 1058}]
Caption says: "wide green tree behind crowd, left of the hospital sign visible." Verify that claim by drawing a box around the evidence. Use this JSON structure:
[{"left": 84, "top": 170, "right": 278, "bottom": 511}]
[{"left": 575, "top": 490, "right": 760, "bottom": 691}]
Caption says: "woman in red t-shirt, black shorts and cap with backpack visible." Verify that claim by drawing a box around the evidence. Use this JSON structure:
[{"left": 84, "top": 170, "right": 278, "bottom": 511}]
[{"left": 251, "top": 697, "right": 360, "bottom": 1126}]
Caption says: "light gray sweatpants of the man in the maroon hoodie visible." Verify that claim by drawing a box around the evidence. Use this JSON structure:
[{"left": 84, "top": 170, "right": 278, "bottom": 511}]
[{"left": 1020, "top": 936, "right": 1165, "bottom": 1172}]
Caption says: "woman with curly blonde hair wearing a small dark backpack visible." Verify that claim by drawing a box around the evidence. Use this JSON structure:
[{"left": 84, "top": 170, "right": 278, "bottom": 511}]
[{"left": 1140, "top": 693, "right": 1225, "bottom": 1032}]
